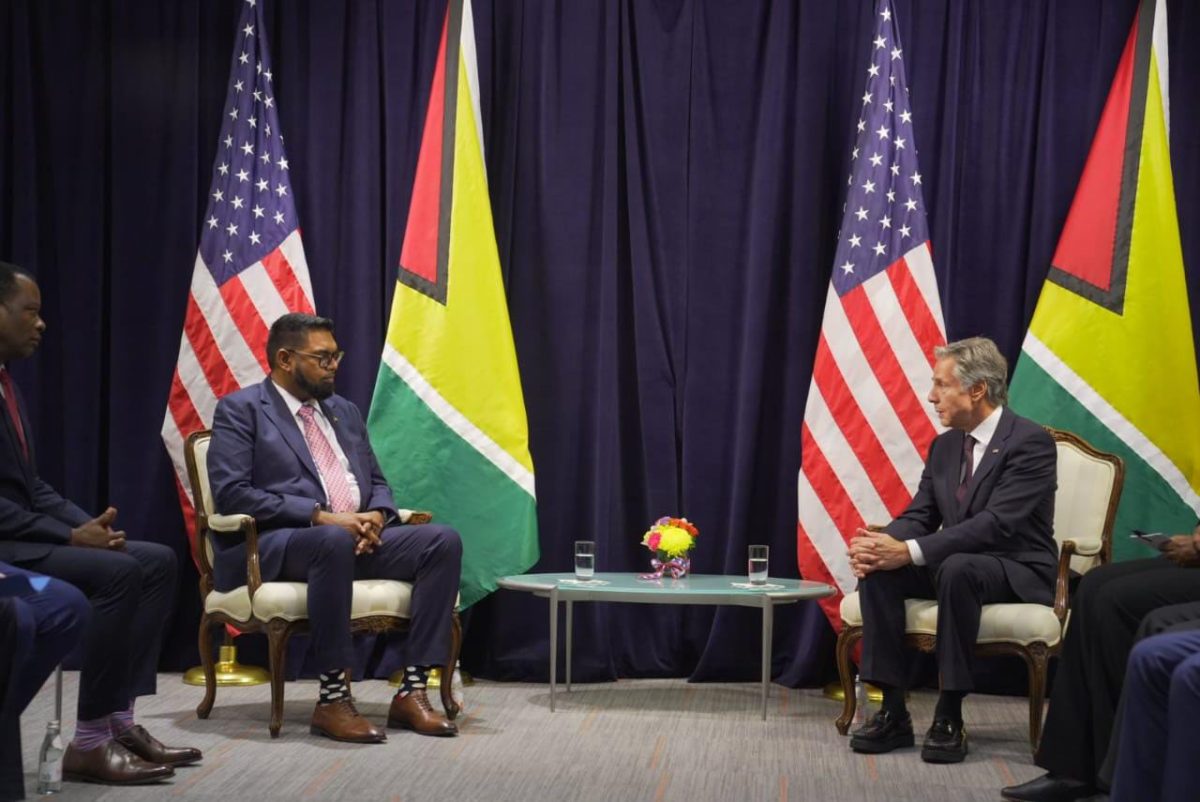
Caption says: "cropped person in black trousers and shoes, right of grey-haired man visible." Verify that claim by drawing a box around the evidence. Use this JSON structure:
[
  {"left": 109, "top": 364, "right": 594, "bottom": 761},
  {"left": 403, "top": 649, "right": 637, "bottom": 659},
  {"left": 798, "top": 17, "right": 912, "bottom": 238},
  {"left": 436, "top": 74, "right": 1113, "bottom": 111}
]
[{"left": 1001, "top": 526, "right": 1200, "bottom": 802}]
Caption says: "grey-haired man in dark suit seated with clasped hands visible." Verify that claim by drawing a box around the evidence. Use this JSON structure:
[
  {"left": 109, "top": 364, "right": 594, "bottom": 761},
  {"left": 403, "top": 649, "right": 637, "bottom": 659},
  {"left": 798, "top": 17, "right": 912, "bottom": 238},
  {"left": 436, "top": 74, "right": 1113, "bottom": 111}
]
[{"left": 850, "top": 337, "right": 1058, "bottom": 762}]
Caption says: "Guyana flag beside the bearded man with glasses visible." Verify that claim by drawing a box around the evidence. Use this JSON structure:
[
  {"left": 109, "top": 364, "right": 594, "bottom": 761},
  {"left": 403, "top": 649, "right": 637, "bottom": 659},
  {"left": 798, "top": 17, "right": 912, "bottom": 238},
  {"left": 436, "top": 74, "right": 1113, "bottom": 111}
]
[{"left": 367, "top": 0, "right": 538, "bottom": 606}]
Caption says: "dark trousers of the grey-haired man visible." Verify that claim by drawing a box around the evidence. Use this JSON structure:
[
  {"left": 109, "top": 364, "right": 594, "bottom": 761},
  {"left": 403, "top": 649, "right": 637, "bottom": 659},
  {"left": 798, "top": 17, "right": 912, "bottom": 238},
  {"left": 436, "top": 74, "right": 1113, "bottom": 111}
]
[{"left": 858, "top": 553, "right": 1018, "bottom": 690}]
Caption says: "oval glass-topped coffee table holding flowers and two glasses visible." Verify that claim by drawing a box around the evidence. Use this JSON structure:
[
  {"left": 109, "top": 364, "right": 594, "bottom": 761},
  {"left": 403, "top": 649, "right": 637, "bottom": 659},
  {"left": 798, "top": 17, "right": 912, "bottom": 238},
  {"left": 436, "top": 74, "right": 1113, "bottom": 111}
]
[{"left": 499, "top": 574, "right": 834, "bottom": 720}]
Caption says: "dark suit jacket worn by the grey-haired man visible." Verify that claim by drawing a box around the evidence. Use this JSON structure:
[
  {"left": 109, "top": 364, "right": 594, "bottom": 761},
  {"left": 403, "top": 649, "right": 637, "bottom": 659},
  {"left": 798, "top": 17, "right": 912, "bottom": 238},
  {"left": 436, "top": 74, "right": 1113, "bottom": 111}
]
[{"left": 886, "top": 407, "right": 1058, "bottom": 604}]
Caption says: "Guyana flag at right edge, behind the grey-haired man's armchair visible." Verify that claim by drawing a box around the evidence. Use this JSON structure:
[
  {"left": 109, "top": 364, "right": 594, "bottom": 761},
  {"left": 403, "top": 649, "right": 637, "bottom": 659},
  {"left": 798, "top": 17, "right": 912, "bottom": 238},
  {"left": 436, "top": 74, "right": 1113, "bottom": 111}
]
[{"left": 1012, "top": 0, "right": 1200, "bottom": 558}]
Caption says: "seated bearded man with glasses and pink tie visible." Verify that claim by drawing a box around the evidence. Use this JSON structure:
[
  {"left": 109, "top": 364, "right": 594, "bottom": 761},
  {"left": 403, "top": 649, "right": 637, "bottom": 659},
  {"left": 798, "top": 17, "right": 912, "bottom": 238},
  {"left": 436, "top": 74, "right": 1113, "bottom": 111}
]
[{"left": 208, "top": 313, "right": 462, "bottom": 743}]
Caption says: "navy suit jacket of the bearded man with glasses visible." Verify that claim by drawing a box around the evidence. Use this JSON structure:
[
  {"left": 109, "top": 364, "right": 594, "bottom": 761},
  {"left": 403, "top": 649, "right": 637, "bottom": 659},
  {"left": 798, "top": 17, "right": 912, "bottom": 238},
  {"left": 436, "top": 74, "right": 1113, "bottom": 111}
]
[{"left": 208, "top": 377, "right": 396, "bottom": 591}]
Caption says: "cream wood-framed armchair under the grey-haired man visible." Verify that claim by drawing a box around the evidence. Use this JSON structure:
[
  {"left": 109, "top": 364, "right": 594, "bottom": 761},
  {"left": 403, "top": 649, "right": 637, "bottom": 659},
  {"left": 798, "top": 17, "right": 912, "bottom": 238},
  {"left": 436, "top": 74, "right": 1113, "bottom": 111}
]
[{"left": 835, "top": 426, "right": 1124, "bottom": 749}]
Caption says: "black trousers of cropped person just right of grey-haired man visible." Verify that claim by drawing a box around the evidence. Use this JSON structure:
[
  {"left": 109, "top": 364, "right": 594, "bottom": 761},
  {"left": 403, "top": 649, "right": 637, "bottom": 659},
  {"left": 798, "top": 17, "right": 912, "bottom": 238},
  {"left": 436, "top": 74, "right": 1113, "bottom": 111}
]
[{"left": 1033, "top": 557, "right": 1200, "bottom": 783}]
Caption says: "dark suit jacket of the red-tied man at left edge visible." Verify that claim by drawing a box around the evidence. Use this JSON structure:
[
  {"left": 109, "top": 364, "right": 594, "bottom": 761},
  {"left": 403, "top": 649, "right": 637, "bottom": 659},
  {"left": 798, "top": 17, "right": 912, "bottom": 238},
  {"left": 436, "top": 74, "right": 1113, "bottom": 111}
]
[{"left": 0, "top": 372, "right": 92, "bottom": 563}]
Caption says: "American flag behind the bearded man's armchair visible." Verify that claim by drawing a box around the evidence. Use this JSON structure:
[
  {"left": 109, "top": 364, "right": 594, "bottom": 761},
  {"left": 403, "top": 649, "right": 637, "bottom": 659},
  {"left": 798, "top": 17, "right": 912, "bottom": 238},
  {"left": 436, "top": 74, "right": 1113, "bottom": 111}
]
[{"left": 162, "top": 0, "right": 313, "bottom": 537}]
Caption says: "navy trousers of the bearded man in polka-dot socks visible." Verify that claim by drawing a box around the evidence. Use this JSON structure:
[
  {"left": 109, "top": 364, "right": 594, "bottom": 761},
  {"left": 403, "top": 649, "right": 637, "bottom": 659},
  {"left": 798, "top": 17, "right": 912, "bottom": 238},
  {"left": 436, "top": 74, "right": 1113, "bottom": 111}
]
[{"left": 277, "top": 523, "right": 462, "bottom": 671}]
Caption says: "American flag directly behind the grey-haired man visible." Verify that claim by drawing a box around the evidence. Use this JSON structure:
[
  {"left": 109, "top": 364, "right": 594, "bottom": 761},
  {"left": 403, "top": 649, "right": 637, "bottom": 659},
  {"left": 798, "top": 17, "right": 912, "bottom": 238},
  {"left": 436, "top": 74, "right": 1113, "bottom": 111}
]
[{"left": 797, "top": 0, "right": 946, "bottom": 627}]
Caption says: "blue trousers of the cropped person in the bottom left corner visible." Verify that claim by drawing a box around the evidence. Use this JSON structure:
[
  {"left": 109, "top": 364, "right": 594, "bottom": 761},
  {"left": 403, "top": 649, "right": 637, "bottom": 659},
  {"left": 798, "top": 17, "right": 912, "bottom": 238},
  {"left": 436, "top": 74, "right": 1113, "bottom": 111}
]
[{"left": 0, "top": 576, "right": 91, "bottom": 801}]
